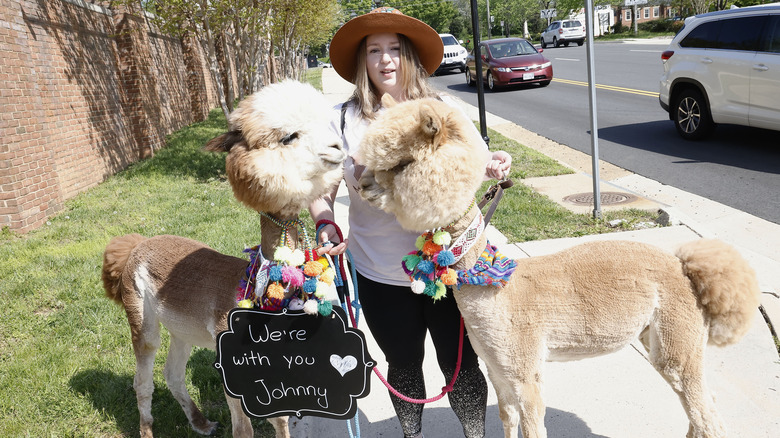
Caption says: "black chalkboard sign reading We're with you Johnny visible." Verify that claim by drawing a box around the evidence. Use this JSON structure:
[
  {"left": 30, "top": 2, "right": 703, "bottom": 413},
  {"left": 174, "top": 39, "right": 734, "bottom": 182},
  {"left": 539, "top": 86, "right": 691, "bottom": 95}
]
[{"left": 214, "top": 306, "right": 376, "bottom": 419}]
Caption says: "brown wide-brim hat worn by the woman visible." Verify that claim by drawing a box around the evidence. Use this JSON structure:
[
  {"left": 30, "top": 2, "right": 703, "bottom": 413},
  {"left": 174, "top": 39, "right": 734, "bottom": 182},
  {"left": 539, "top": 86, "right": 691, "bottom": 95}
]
[{"left": 330, "top": 7, "right": 444, "bottom": 83}]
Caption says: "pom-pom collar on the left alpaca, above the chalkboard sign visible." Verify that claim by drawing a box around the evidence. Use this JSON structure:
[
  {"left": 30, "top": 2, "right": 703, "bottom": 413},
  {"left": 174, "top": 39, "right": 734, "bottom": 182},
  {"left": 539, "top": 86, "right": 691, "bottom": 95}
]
[{"left": 236, "top": 214, "right": 336, "bottom": 316}]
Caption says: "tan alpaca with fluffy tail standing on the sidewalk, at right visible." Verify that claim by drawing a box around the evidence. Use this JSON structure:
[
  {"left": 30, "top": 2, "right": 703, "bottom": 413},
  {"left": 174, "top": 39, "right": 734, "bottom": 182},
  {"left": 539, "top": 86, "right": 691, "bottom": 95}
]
[{"left": 360, "top": 95, "right": 759, "bottom": 438}]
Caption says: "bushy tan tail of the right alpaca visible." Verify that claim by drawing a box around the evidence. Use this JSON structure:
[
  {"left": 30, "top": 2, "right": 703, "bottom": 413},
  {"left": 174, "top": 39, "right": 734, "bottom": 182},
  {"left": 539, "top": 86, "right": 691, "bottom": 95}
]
[{"left": 677, "top": 239, "right": 761, "bottom": 347}]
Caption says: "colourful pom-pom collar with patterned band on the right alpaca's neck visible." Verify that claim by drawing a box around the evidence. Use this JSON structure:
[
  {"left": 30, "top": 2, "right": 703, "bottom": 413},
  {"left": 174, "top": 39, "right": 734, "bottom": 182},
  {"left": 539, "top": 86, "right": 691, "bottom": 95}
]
[{"left": 401, "top": 207, "right": 517, "bottom": 301}]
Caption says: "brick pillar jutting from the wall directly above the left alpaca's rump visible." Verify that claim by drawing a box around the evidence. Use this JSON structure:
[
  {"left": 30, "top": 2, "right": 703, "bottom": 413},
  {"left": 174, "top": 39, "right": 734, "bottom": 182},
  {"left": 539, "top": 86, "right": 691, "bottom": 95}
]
[{"left": 114, "top": 8, "right": 165, "bottom": 158}]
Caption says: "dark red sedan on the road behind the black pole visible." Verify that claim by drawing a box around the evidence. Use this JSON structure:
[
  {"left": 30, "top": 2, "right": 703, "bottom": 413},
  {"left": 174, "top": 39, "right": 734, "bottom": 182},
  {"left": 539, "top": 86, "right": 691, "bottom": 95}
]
[{"left": 466, "top": 38, "right": 553, "bottom": 90}]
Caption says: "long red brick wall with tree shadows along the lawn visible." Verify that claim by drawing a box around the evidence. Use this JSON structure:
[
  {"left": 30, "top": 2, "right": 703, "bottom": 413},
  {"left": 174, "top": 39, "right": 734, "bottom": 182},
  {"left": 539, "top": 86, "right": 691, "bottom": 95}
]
[{"left": 0, "top": 0, "right": 225, "bottom": 232}]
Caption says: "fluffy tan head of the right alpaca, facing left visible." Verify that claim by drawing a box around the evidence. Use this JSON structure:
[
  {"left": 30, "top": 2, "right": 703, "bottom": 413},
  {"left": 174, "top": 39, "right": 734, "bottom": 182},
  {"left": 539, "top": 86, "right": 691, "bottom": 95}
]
[{"left": 356, "top": 95, "right": 488, "bottom": 231}]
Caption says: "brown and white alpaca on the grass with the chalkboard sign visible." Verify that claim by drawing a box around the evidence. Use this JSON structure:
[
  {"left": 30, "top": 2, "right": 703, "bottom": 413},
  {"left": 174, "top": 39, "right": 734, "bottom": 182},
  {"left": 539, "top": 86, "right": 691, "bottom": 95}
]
[{"left": 103, "top": 81, "right": 345, "bottom": 437}]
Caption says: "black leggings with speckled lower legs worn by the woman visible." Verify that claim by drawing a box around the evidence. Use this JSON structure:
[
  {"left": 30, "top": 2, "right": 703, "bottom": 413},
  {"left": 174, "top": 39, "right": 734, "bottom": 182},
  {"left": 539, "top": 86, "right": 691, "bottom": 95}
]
[{"left": 357, "top": 273, "right": 487, "bottom": 438}]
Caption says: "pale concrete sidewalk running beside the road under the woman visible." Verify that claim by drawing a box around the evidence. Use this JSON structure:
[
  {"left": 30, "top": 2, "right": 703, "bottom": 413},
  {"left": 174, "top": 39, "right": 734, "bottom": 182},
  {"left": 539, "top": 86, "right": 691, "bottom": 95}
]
[{"left": 290, "top": 69, "right": 780, "bottom": 438}]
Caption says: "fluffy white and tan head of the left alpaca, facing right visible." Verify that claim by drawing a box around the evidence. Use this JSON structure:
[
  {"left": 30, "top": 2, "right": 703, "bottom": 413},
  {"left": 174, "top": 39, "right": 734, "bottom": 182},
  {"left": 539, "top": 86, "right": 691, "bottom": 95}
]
[{"left": 206, "top": 80, "right": 346, "bottom": 219}]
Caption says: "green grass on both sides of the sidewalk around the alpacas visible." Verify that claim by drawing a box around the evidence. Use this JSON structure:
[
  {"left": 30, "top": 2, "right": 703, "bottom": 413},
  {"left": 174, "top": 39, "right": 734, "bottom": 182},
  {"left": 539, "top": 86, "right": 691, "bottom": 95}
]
[{"left": 0, "top": 69, "right": 660, "bottom": 437}]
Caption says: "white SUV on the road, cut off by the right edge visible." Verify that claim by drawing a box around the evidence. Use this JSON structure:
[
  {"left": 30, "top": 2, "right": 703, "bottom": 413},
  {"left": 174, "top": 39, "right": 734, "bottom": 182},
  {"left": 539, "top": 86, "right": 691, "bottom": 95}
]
[{"left": 658, "top": 5, "right": 780, "bottom": 140}]
